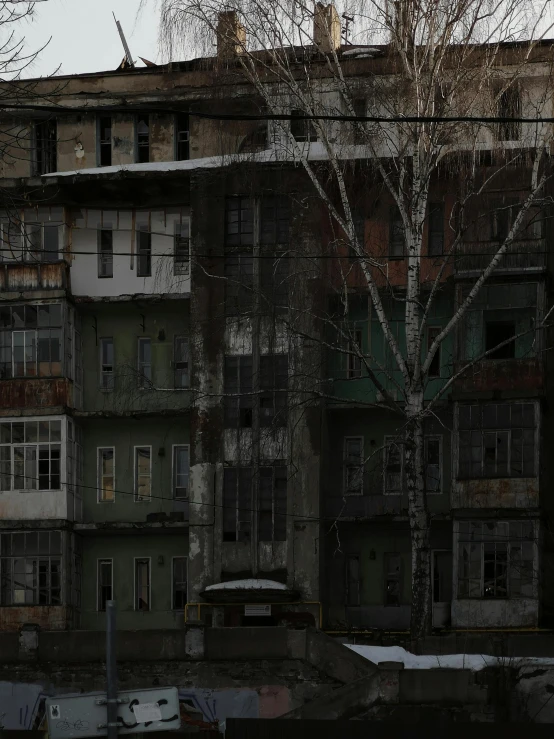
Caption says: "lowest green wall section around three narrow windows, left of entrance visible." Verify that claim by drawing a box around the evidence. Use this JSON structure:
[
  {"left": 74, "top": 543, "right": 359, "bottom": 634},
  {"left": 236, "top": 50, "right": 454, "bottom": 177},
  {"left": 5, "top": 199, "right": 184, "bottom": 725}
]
[{"left": 81, "top": 531, "right": 188, "bottom": 630}]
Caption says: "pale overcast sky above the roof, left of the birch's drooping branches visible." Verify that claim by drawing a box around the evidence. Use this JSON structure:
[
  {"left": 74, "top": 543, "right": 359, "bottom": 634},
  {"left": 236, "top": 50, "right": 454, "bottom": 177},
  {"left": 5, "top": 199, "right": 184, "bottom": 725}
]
[{"left": 24, "top": 0, "right": 162, "bottom": 77}]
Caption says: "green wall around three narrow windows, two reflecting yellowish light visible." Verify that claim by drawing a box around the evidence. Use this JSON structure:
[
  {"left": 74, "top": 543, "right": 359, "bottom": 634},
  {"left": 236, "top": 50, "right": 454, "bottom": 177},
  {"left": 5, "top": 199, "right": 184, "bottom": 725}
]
[{"left": 81, "top": 415, "right": 189, "bottom": 522}]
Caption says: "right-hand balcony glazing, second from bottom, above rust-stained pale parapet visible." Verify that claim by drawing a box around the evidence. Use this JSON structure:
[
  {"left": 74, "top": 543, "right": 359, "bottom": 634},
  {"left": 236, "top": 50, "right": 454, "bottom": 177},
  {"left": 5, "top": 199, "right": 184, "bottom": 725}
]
[{"left": 458, "top": 403, "right": 537, "bottom": 479}]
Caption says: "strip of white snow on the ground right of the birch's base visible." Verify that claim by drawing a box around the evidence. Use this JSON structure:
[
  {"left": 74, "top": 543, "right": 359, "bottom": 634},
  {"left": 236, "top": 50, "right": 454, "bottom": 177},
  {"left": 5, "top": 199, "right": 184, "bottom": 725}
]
[{"left": 344, "top": 644, "right": 554, "bottom": 672}]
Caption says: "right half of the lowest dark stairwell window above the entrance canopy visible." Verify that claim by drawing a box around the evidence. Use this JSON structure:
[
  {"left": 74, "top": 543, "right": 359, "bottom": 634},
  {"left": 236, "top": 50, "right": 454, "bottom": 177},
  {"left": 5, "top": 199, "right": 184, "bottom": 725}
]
[{"left": 258, "top": 465, "right": 287, "bottom": 541}]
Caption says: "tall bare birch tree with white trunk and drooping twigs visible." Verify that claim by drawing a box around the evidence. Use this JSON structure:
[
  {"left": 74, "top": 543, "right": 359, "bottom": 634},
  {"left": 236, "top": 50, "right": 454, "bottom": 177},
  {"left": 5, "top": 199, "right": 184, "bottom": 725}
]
[{"left": 154, "top": 0, "right": 552, "bottom": 638}]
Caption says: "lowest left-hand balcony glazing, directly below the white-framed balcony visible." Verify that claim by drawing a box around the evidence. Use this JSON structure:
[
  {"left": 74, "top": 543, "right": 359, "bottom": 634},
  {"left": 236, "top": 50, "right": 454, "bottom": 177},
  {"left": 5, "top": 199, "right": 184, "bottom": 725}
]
[{"left": 0, "top": 531, "right": 62, "bottom": 606}]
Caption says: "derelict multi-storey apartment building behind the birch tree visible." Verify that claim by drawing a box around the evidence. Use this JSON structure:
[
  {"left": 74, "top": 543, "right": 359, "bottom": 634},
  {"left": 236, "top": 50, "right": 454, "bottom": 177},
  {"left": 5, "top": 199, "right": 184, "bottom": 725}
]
[{"left": 0, "top": 2, "right": 553, "bottom": 656}]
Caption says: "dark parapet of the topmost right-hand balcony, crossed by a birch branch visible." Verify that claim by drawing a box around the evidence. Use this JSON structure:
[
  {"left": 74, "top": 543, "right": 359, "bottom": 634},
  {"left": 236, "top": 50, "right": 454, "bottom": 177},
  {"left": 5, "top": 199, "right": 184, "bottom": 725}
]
[{"left": 454, "top": 239, "right": 546, "bottom": 276}]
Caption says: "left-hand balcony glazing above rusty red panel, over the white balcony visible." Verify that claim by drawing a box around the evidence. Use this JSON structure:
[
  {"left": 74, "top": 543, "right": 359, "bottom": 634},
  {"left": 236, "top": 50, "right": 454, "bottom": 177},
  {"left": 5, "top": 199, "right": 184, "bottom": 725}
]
[{"left": 0, "top": 303, "right": 63, "bottom": 380}]
